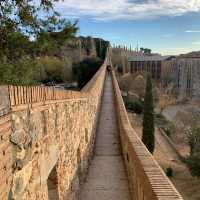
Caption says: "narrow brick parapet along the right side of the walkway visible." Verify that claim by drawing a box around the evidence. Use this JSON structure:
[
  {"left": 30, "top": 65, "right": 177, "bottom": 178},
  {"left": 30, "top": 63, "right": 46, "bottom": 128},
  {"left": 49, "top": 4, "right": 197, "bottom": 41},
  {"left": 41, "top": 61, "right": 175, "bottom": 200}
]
[{"left": 112, "top": 69, "right": 183, "bottom": 200}]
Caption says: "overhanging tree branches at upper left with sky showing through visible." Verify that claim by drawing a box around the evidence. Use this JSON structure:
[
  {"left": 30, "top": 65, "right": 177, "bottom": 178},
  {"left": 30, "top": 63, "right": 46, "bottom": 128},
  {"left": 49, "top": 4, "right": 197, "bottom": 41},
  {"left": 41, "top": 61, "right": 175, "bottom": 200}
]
[{"left": 0, "top": 0, "right": 77, "bottom": 60}]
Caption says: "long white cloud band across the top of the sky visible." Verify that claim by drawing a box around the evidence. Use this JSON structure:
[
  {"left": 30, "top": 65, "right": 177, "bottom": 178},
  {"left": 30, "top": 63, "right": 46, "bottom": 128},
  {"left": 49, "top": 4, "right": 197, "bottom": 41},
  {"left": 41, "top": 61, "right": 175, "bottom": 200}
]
[{"left": 57, "top": 0, "right": 200, "bottom": 21}]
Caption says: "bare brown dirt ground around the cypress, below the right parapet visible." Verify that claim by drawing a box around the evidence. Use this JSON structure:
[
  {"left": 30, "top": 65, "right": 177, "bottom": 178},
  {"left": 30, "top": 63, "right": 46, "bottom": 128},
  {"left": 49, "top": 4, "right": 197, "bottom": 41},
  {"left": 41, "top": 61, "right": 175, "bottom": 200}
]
[{"left": 128, "top": 113, "right": 200, "bottom": 200}]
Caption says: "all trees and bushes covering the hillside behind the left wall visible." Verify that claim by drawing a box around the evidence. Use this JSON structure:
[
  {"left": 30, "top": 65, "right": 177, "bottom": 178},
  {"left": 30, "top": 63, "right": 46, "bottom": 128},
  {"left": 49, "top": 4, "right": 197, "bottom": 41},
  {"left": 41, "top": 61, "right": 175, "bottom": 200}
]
[{"left": 0, "top": 0, "right": 108, "bottom": 86}]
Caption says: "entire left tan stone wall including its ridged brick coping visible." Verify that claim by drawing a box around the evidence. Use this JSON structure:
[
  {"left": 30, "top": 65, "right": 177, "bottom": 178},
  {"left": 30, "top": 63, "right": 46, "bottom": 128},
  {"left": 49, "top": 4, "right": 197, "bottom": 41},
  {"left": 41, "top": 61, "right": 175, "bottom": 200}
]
[{"left": 0, "top": 56, "right": 107, "bottom": 200}]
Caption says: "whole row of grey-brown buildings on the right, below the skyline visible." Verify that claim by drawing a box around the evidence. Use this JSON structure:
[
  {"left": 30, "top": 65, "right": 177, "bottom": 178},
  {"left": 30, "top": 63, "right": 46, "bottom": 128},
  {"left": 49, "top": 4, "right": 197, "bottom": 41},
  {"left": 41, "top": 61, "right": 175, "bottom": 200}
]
[{"left": 128, "top": 55, "right": 200, "bottom": 99}]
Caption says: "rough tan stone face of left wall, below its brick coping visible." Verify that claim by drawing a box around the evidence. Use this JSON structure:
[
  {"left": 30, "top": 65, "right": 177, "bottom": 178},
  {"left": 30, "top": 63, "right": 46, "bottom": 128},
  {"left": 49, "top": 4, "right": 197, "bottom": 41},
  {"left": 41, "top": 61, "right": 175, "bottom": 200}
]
[{"left": 6, "top": 63, "right": 105, "bottom": 200}]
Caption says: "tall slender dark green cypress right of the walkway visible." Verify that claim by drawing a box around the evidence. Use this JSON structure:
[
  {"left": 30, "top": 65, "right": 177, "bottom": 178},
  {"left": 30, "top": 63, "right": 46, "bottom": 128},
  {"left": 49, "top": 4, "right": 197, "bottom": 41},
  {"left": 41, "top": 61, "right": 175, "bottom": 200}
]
[{"left": 142, "top": 74, "right": 155, "bottom": 153}]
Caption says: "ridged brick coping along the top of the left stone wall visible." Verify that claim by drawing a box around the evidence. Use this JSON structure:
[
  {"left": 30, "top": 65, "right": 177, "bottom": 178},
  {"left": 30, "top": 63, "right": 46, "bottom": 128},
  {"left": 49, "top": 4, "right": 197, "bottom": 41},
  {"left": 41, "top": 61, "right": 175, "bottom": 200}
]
[{"left": 0, "top": 53, "right": 107, "bottom": 113}]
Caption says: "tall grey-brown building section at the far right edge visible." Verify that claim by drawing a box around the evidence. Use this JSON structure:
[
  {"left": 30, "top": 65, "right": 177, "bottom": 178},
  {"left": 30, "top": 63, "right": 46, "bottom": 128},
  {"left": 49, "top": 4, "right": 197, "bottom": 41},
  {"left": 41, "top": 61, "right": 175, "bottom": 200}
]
[{"left": 162, "top": 57, "right": 200, "bottom": 101}]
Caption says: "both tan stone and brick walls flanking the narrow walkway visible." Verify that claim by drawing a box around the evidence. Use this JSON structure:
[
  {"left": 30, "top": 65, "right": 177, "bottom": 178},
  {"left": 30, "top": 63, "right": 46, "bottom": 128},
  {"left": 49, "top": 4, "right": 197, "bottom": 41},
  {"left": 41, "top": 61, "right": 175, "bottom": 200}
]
[{"left": 0, "top": 47, "right": 183, "bottom": 200}]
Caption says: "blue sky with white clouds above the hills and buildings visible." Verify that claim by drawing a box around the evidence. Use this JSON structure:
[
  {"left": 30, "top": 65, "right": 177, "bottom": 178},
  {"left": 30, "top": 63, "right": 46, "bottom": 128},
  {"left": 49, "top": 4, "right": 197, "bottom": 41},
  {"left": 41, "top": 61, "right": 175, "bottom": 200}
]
[{"left": 56, "top": 0, "right": 200, "bottom": 55}]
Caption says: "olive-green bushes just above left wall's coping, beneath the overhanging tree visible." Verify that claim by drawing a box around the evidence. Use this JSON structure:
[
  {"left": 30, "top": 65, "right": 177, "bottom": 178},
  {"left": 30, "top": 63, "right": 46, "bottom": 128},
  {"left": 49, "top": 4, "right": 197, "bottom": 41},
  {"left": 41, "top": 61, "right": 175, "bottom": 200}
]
[{"left": 0, "top": 56, "right": 72, "bottom": 85}]
